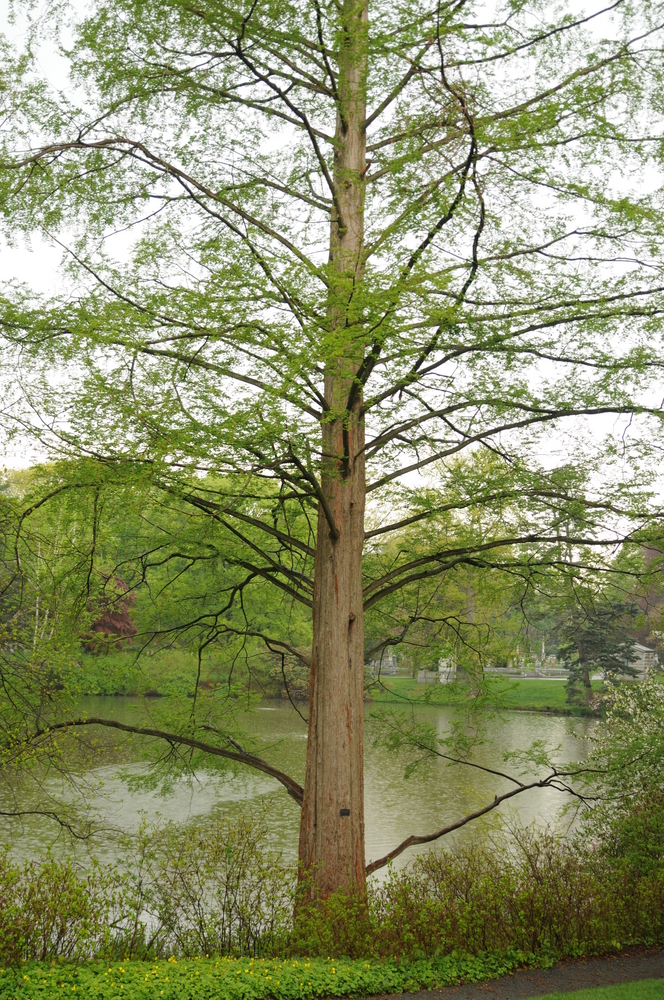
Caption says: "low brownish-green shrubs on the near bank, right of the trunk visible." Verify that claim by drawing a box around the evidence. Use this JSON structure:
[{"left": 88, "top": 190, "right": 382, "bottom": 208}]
[{"left": 290, "top": 830, "right": 664, "bottom": 962}]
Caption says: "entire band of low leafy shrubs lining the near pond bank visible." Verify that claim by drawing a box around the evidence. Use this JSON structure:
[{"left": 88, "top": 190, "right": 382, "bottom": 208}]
[{"left": 0, "top": 806, "right": 664, "bottom": 965}]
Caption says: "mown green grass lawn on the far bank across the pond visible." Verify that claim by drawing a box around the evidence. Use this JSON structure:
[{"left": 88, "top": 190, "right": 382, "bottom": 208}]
[{"left": 369, "top": 677, "right": 603, "bottom": 715}]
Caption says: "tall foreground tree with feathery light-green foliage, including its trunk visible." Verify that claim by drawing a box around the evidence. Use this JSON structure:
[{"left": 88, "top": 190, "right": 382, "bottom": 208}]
[{"left": 0, "top": 0, "right": 664, "bottom": 894}]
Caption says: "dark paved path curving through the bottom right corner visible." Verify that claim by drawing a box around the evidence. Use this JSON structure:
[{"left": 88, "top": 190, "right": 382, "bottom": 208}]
[{"left": 378, "top": 948, "right": 664, "bottom": 1000}]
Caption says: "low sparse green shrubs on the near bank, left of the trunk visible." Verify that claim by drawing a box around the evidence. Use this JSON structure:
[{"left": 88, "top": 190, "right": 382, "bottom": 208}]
[{"left": 0, "top": 820, "right": 296, "bottom": 964}]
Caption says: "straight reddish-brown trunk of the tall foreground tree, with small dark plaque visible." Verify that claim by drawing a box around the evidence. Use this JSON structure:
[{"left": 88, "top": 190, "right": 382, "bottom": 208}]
[{"left": 300, "top": 0, "right": 367, "bottom": 898}]
